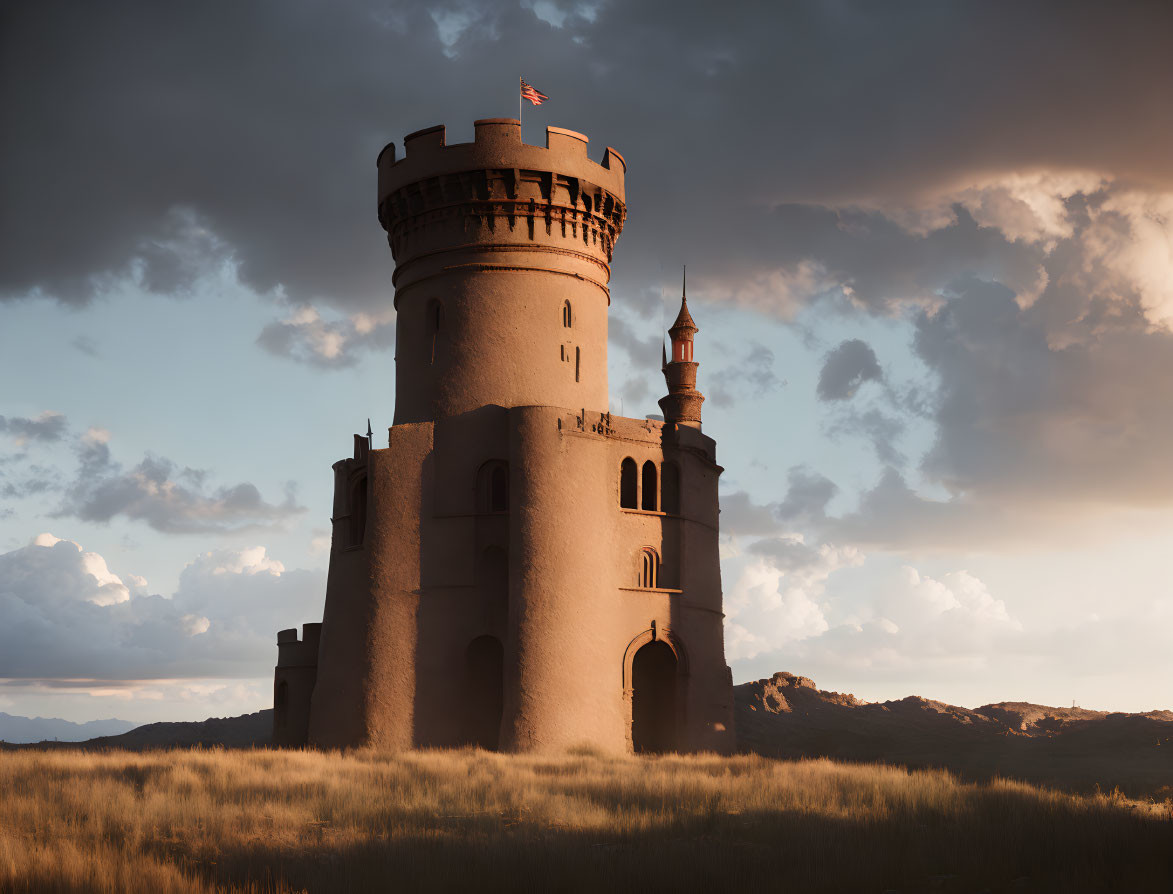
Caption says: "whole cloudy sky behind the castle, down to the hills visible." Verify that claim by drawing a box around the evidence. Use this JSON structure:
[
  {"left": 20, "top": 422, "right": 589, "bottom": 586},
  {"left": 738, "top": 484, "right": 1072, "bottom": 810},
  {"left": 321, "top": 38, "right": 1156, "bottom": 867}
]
[{"left": 0, "top": 0, "right": 1173, "bottom": 722}]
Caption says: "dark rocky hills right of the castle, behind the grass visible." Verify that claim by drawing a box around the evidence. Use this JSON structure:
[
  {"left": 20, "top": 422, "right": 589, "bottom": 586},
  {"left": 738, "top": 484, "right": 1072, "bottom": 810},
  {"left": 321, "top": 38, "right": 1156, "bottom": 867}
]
[{"left": 733, "top": 672, "right": 1173, "bottom": 798}]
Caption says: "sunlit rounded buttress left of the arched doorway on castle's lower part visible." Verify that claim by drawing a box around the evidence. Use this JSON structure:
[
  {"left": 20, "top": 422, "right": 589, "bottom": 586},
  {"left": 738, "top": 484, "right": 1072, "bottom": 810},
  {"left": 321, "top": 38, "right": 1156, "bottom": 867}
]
[{"left": 506, "top": 407, "right": 624, "bottom": 751}]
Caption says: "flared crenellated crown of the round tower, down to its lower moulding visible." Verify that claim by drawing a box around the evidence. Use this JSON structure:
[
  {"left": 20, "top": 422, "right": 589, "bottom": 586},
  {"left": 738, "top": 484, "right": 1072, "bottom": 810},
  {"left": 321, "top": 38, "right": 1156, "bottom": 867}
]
[{"left": 378, "top": 118, "right": 626, "bottom": 290}]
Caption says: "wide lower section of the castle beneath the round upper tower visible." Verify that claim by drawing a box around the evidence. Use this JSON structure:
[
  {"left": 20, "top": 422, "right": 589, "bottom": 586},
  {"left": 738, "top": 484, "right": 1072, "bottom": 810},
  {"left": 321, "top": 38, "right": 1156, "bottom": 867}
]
[{"left": 293, "top": 407, "right": 733, "bottom": 752}]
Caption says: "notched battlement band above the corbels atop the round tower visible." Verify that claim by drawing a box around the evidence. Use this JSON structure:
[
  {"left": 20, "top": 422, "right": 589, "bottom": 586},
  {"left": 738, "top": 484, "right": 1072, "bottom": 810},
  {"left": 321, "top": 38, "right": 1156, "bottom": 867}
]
[{"left": 375, "top": 118, "right": 628, "bottom": 205}]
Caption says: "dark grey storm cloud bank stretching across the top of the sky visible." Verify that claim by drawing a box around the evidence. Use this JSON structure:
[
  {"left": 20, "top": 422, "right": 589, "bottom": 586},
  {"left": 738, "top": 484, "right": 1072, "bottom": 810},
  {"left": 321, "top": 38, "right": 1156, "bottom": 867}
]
[{"left": 0, "top": 0, "right": 1173, "bottom": 312}]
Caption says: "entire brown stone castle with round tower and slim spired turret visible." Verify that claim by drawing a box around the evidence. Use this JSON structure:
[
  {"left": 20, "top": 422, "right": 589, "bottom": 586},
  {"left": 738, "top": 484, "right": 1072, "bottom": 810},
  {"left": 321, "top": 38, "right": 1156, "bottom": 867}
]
[{"left": 273, "top": 118, "right": 733, "bottom": 752}]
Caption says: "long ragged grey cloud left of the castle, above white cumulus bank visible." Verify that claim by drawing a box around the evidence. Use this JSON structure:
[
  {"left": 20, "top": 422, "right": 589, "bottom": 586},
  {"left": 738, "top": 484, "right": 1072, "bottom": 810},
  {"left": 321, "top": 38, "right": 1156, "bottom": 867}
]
[{"left": 55, "top": 435, "right": 304, "bottom": 534}]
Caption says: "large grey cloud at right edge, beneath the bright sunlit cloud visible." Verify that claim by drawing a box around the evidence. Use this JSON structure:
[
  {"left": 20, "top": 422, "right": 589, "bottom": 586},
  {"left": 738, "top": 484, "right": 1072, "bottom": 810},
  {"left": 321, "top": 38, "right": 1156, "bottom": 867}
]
[{"left": 916, "top": 278, "right": 1173, "bottom": 504}]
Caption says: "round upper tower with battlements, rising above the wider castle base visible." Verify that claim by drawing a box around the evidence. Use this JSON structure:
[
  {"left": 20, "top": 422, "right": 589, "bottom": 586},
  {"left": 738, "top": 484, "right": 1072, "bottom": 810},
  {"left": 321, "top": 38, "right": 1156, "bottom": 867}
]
[{"left": 378, "top": 118, "right": 626, "bottom": 425}]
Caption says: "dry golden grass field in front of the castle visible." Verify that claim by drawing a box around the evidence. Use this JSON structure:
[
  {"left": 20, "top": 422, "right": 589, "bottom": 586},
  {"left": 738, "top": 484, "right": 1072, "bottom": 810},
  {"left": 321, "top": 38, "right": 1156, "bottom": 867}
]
[{"left": 0, "top": 750, "right": 1173, "bottom": 894}]
